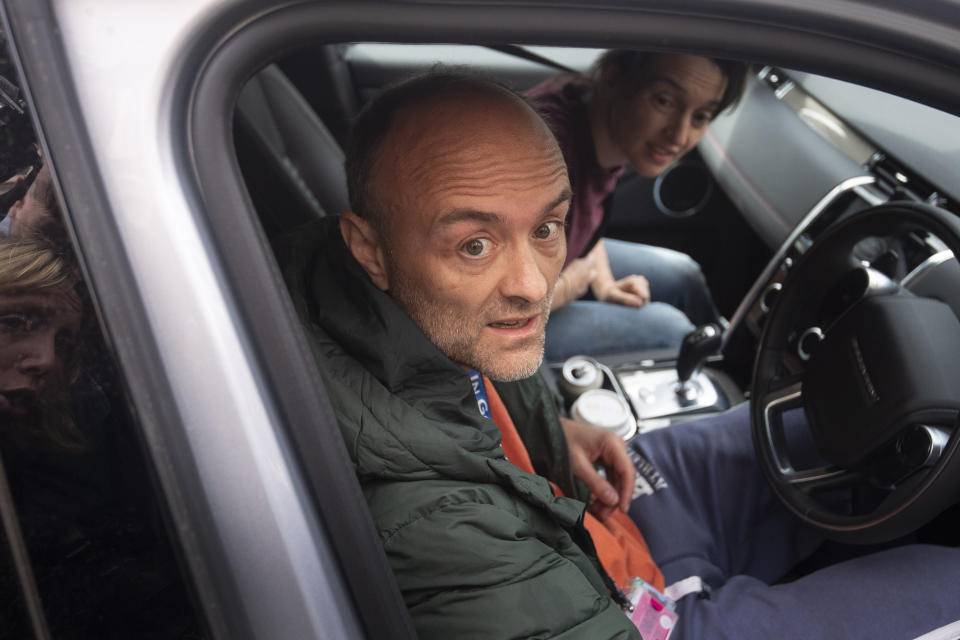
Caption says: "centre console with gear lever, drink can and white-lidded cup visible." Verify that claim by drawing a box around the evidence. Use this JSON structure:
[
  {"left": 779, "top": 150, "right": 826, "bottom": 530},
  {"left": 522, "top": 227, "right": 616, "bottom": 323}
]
[{"left": 544, "top": 161, "right": 876, "bottom": 438}]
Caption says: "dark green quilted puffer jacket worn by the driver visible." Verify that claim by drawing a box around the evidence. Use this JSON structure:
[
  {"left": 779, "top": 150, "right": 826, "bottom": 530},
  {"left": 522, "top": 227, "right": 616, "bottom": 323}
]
[{"left": 276, "top": 219, "right": 640, "bottom": 640}]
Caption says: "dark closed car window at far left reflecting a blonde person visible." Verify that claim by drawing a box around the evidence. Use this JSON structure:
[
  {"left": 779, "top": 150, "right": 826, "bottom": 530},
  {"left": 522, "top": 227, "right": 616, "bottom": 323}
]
[{"left": 0, "top": 33, "right": 205, "bottom": 639}]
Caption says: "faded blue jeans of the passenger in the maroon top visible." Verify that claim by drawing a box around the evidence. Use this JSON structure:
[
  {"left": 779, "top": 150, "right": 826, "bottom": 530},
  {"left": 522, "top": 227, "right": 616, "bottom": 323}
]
[{"left": 544, "top": 238, "right": 720, "bottom": 362}]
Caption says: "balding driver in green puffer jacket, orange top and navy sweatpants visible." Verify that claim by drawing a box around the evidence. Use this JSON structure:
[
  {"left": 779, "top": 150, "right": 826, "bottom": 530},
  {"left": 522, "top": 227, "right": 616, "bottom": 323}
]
[{"left": 277, "top": 72, "right": 960, "bottom": 638}]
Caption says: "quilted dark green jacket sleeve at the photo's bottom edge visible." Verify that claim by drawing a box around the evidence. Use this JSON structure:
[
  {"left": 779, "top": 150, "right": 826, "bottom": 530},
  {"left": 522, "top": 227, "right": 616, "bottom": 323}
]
[{"left": 384, "top": 502, "right": 640, "bottom": 640}]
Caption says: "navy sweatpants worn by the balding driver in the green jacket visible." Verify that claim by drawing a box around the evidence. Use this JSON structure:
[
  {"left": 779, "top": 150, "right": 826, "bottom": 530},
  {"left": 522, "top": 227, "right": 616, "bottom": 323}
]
[{"left": 629, "top": 404, "right": 960, "bottom": 640}]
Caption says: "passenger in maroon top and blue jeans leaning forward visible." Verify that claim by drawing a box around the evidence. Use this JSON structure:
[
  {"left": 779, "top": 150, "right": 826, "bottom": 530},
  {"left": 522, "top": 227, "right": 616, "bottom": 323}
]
[{"left": 526, "top": 49, "right": 746, "bottom": 361}]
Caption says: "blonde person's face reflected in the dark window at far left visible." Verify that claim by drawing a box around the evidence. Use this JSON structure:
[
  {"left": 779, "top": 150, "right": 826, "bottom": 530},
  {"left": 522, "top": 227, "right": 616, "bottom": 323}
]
[{"left": 0, "top": 286, "right": 81, "bottom": 418}]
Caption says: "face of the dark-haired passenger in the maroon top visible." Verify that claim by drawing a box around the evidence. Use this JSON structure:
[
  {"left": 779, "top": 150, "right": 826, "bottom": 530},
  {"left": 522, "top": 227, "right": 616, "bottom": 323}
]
[{"left": 607, "top": 54, "right": 727, "bottom": 178}]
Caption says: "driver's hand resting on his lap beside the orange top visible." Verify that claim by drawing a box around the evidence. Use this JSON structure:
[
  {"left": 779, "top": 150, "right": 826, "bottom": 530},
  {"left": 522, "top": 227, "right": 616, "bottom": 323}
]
[{"left": 560, "top": 418, "right": 637, "bottom": 520}]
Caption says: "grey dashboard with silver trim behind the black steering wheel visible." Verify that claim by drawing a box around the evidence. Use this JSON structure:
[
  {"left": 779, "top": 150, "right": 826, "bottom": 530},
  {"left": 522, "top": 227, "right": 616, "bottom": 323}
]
[{"left": 700, "top": 67, "right": 960, "bottom": 359}]
